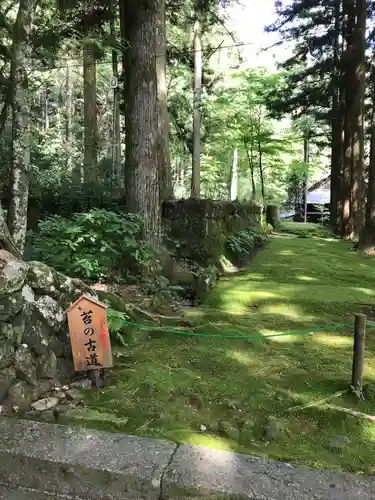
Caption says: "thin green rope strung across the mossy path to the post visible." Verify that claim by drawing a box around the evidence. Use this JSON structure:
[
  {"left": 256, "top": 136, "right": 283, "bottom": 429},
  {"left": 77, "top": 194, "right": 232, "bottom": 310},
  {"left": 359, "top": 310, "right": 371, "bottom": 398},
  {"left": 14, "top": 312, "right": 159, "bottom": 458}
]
[{"left": 124, "top": 320, "right": 354, "bottom": 340}]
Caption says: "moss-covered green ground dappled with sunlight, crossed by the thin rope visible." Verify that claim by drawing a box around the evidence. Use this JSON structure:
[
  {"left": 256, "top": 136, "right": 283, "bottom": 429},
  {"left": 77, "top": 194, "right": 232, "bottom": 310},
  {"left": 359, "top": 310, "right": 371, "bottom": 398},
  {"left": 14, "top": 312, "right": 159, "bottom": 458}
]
[{"left": 58, "top": 223, "right": 375, "bottom": 474}]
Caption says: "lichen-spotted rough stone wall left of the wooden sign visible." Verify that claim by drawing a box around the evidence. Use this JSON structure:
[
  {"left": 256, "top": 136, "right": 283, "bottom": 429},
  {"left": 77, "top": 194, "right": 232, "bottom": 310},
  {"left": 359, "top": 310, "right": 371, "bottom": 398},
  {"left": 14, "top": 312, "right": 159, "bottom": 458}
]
[{"left": 0, "top": 250, "right": 94, "bottom": 413}]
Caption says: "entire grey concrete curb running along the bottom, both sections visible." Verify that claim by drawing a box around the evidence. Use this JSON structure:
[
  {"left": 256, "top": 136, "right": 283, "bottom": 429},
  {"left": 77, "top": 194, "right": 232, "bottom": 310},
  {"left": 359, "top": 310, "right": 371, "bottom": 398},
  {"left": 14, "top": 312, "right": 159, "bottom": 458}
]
[{"left": 0, "top": 418, "right": 375, "bottom": 500}]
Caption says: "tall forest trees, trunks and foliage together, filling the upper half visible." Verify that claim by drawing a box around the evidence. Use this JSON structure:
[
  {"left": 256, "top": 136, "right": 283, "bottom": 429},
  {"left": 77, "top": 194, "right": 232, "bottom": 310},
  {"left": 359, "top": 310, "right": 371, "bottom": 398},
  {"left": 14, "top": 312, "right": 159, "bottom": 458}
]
[{"left": 0, "top": 0, "right": 374, "bottom": 249}]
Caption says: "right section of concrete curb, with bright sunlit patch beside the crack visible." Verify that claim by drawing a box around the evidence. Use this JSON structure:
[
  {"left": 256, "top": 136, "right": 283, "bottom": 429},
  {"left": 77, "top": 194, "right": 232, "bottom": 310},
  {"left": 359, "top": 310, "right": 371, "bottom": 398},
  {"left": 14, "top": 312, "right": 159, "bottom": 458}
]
[{"left": 162, "top": 446, "right": 375, "bottom": 500}]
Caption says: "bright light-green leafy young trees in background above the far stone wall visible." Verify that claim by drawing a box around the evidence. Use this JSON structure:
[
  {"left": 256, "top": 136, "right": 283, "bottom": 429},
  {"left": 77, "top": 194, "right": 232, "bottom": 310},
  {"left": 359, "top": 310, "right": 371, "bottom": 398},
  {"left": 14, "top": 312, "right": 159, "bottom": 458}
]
[{"left": 202, "top": 68, "right": 304, "bottom": 201}]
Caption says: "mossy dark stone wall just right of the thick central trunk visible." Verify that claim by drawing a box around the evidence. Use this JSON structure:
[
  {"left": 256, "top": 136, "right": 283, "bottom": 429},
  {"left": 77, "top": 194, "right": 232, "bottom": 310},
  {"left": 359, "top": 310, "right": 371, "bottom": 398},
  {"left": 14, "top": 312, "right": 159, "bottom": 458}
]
[{"left": 162, "top": 200, "right": 261, "bottom": 265}]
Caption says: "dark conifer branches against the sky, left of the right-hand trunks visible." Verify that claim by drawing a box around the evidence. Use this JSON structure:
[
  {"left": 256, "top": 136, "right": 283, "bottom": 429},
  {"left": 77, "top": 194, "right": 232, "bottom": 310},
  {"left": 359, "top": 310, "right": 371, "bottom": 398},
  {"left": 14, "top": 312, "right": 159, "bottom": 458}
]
[{"left": 267, "top": 0, "right": 339, "bottom": 127}]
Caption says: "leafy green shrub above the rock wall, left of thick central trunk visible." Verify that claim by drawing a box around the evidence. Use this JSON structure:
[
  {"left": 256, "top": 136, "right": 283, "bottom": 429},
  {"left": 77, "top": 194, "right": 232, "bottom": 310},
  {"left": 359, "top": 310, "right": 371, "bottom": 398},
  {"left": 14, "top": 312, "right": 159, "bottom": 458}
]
[{"left": 30, "top": 209, "right": 153, "bottom": 280}]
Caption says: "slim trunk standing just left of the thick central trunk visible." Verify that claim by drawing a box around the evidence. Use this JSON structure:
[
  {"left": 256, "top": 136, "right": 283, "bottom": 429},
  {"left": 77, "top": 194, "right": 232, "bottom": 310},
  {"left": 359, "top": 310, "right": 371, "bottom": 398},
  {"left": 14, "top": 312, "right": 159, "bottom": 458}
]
[{"left": 109, "top": 0, "right": 122, "bottom": 186}]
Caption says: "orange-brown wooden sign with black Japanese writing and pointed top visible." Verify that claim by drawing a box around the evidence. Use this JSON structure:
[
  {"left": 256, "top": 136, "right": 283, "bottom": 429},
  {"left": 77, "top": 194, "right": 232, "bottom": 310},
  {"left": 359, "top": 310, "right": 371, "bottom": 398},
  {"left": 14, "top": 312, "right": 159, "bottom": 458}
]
[{"left": 66, "top": 295, "right": 113, "bottom": 372}]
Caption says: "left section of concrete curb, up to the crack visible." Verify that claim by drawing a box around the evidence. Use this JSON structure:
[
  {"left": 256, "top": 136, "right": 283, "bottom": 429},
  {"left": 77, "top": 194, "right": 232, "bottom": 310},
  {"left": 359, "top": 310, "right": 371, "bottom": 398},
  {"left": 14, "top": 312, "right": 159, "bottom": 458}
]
[{"left": 0, "top": 418, "right": 176, "bottom": 500}]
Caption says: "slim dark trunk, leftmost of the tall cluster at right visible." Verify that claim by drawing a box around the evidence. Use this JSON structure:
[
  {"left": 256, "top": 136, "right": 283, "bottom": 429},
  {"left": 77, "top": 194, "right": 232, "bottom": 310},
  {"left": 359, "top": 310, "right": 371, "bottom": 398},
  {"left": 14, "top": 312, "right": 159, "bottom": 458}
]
[{"left": 330, "top": 0, "right": 342, "bottom": 232}]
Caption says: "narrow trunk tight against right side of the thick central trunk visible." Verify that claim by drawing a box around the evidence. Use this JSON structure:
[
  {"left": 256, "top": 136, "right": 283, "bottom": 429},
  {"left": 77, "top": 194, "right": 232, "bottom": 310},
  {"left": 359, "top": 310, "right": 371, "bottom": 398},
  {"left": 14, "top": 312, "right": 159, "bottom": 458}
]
[{"left": 156, "top": 0, "right": 174, "bottom": 202}]
